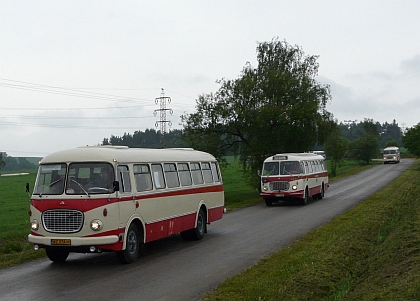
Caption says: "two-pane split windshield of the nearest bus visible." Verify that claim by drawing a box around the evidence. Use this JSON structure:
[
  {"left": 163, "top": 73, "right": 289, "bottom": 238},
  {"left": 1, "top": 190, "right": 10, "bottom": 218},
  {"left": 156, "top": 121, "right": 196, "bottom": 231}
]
[{"left": 34, "top": 163, "right": 114, "bottom": 196}]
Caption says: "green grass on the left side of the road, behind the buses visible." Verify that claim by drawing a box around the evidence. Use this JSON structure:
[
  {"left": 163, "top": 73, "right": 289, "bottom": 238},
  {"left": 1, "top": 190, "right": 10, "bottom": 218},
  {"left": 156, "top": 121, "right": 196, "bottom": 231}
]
[{"left": 0, "top": 157, "right": 388, "bottom": 268}]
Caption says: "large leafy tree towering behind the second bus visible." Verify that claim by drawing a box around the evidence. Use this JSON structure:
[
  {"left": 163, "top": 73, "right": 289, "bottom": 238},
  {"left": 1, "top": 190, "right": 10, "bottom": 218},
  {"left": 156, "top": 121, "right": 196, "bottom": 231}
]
[{"left": 183, "top": 39, "right": 335, "bottom": 185}]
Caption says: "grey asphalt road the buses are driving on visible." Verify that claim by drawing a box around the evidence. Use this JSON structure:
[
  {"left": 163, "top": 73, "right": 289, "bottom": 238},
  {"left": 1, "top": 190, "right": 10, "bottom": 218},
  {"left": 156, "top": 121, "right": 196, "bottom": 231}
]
[{"left": 0, "top": 160, "right": 414, "bottom": 301}]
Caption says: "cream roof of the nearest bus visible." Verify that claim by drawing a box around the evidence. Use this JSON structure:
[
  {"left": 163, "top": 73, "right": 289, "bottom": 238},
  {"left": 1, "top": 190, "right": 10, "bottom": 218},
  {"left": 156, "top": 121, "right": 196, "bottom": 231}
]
[{"left": 40, "top": 145, "right": 216, "bottom": 164}]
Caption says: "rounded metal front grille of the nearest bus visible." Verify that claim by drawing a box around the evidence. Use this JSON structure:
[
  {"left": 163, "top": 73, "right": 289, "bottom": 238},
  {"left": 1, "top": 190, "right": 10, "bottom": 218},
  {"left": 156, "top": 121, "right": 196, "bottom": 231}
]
[{"left": 42, "top": 210, "right": 83, "bottom": 233}]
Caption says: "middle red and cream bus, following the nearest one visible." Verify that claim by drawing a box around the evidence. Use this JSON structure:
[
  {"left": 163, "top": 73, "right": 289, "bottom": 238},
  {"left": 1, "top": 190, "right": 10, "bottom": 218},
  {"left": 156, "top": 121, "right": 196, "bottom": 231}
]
[{"left": 260, "top": 153, "right": 329, "bottom": 206}]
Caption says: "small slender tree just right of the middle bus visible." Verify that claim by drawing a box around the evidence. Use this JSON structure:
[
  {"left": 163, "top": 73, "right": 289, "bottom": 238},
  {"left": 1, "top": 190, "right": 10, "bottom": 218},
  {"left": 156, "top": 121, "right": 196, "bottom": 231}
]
[{"left": 324, "top": 125, "right": 349, "bottom": 177}]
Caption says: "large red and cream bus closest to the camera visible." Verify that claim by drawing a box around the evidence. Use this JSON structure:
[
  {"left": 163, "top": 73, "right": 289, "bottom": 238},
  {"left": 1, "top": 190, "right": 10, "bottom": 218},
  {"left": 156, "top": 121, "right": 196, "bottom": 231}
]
[{"left": 27, "top": 146, "right": 224, "bottom": 263}]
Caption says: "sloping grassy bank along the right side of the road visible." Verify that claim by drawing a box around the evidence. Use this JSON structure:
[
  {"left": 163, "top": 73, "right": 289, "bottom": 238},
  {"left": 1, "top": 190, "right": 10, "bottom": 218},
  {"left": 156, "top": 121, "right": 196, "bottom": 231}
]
[{"left": 204, "top": 161, "right": 420, "bottom": 301}]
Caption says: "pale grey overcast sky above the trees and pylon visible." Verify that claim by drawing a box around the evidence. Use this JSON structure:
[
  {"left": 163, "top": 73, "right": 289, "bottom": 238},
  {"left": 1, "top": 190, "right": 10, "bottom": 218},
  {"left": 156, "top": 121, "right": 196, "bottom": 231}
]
[{"left": 0, "top": 0, "right": 420, "bottom": 157}]
